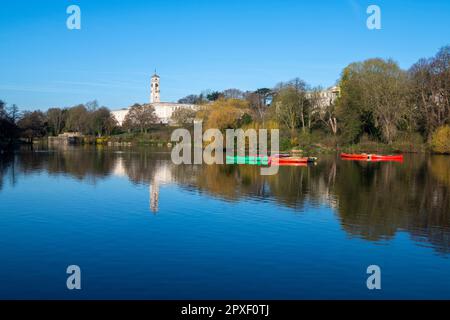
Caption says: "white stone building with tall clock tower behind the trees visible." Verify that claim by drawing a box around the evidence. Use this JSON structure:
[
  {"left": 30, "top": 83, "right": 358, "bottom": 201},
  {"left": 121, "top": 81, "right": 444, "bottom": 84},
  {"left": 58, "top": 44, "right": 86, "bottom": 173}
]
[{"left": 111, "top": 73, "right": 198, "bottom": 125}]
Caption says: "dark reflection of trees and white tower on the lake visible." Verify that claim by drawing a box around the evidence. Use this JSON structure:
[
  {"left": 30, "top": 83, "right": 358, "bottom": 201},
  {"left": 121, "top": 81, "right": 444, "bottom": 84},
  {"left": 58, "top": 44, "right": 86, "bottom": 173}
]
[{"left": 0, "top": 147, "right": 450, "bottom": 254}]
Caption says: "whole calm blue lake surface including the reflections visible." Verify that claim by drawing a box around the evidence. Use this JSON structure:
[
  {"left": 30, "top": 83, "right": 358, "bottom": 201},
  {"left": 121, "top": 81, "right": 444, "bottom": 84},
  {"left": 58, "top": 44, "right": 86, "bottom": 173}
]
[{"left": 0, "top": 147, "right": 450, "bottom": 299}]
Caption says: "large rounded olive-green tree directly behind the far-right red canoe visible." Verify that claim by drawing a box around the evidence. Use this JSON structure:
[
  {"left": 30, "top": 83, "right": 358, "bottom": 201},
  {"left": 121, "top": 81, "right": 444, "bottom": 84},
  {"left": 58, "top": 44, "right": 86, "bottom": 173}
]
[{"left": 338, "top": 59, "right": 409, "bottom": 143}]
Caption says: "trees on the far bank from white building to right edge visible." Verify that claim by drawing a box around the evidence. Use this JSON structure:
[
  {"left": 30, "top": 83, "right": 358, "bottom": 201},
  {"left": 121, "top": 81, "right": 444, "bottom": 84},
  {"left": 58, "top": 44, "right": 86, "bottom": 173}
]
[{"left": 174, "top": 46, "right": 450, "bottom": 152}]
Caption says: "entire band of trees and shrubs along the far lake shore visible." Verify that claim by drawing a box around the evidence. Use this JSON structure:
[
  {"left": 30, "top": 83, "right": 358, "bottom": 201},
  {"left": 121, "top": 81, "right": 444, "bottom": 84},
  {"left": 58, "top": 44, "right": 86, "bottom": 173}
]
[{"left": 0, "top": 46, "right": 450, "bottom": 153}]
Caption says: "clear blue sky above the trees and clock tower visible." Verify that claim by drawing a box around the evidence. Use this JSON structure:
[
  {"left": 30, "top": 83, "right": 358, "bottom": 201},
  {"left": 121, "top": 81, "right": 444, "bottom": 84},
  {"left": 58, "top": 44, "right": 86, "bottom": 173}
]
[{"left": 0, "top": 0, "right": 450, "bottom": 110}]
